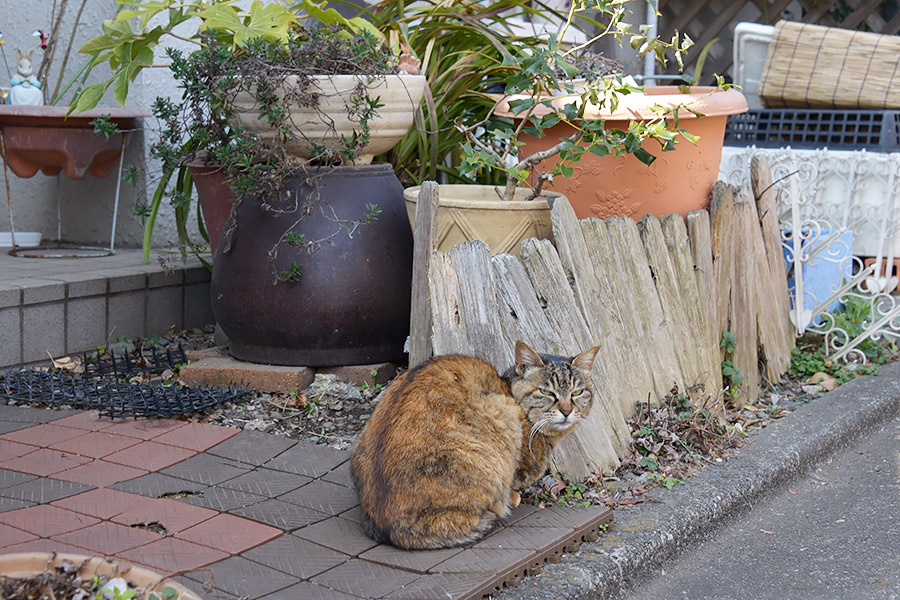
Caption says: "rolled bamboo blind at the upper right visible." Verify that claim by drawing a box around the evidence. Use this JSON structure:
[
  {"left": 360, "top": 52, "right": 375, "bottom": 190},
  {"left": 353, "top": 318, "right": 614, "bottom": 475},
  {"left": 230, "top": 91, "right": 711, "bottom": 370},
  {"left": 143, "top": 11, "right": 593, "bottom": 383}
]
[{"left": 759, "top": 21, "right": 900, "bottom": 109}]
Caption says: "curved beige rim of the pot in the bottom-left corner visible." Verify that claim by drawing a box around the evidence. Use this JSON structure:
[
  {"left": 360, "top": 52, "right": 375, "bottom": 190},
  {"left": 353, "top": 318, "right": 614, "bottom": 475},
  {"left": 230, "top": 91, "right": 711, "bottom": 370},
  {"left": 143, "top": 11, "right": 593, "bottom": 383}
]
[{"left": 0, "top": 552, "right": 200, "bottom": 600}]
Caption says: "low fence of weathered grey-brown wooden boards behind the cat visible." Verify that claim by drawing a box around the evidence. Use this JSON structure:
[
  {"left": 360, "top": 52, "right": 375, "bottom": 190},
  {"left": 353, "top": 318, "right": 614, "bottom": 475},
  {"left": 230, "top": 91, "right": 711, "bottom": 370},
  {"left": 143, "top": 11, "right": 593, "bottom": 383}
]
[{"left": 411, "top": 183, "right": 793, "bottom": 478}]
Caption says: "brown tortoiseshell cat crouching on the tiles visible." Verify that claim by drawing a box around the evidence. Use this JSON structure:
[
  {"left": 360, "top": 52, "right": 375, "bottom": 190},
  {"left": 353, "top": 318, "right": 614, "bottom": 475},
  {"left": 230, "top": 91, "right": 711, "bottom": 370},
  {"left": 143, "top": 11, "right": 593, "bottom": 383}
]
[{"left": 352, "top": 342, "right": 599, "bottom": 549}]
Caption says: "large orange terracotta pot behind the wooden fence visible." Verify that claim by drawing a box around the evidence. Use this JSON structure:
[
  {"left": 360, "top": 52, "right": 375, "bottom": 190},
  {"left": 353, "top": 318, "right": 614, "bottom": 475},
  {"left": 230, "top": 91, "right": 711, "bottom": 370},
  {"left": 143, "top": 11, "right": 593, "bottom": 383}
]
[{"left": 498, "top": 86, "right": 747, "bottom": 220}]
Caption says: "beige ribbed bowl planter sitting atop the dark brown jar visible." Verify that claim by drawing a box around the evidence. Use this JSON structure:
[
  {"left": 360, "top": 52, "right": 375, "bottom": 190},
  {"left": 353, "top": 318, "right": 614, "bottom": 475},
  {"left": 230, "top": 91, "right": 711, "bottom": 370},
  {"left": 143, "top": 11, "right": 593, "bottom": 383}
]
[{"left": 234, "top": 75, "right": 425, "bottom": 165}]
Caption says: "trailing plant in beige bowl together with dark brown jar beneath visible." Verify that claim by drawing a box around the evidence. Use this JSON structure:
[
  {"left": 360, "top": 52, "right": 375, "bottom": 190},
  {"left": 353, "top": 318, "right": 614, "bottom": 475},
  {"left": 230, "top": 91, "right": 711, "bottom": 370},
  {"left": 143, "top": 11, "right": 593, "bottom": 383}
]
[{"left": 75, "top": 0, "right": 424, "bottom": 366}]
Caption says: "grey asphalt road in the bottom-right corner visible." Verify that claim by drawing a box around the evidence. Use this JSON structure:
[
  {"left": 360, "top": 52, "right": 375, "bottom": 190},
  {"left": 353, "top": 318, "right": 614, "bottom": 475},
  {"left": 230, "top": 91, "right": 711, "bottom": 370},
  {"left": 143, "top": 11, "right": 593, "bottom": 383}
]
[{"left": 624, "top": 415, "right": 900, "bottom": 600}]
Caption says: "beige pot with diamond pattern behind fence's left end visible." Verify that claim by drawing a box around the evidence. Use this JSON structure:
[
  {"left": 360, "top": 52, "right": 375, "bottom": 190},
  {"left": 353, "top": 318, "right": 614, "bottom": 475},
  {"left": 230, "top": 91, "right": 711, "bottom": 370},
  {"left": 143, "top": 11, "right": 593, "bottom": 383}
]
[{"left": 403, "top": 185, "right": 562, "bottom": 256}]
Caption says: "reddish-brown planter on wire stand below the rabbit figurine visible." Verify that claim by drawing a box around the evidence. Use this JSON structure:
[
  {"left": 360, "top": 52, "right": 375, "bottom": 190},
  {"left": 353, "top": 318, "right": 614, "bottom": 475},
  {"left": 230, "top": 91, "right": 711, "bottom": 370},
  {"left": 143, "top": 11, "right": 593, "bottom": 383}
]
[{"left": 0, "top": 105, "right": 149, "bottom": 179}]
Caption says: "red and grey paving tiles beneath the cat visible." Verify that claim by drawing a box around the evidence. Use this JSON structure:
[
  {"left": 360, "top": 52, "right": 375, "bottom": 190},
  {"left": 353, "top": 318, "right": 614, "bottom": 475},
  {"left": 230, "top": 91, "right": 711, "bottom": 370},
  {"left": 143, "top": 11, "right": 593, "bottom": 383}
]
[{"left": 0, "top": 406, "right": 611, "bottom": 600}]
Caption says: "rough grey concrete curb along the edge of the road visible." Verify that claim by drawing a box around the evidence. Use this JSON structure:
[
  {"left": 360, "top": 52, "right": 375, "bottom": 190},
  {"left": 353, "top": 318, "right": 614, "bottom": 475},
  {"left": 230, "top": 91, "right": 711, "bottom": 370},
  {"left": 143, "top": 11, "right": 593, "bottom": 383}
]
[{"left": 498, "top": 363, "right": 900, "bottom": 600}]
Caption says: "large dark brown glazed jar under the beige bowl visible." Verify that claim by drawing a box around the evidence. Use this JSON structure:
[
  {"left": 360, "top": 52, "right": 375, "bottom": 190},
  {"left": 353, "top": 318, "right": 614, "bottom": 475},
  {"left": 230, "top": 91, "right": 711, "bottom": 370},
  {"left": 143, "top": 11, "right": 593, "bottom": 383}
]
[{"left": 211, "top": 164, "right": 412, "bottom": 367}]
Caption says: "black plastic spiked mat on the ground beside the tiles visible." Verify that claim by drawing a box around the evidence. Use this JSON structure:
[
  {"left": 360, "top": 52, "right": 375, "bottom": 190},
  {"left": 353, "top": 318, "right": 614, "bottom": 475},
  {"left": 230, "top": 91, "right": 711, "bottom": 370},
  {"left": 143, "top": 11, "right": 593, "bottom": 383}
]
[{"left": 0, "top": 346, "right": 251, "bottom": 419}]
